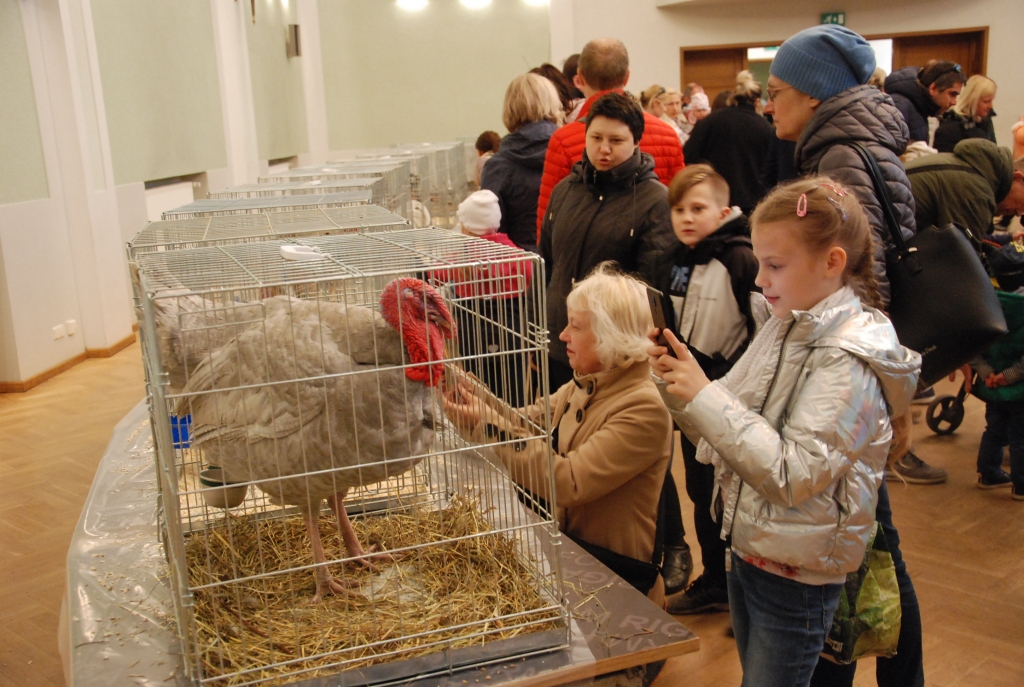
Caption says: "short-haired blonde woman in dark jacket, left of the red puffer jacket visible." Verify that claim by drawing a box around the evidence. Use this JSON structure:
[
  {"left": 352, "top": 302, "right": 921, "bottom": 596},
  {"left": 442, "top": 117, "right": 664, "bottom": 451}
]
[{"left": 480, "top": 74, "right": 563, "bottom": 251}]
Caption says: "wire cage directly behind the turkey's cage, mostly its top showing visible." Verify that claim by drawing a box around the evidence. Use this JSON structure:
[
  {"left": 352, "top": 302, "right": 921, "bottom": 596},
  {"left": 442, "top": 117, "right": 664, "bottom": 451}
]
[{"left": 128, "top": 205, "right": 409, "bottom": 262}]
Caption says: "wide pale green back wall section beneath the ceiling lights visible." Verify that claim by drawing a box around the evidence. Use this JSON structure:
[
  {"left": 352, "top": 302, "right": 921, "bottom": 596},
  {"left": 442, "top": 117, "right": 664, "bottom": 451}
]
[{"left": 318, "top": 0, "right": 551, "bottom": 149}]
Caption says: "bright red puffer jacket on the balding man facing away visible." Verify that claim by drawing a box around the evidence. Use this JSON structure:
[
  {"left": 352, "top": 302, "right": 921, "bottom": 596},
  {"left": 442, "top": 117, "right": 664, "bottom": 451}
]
[{"left": 537, "top": 89, "right": 683, "bottom": 237}]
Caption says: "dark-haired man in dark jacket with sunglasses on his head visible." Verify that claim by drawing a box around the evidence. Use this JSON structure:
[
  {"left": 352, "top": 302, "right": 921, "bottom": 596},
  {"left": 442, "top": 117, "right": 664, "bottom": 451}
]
[{"left": 886, "top": 59, "right": 967, "bottom": 142}]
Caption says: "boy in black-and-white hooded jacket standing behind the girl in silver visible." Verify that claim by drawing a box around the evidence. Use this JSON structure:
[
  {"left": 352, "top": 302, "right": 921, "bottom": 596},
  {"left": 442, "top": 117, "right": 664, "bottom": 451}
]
[{"left": 655, "top": 165, "right": 760, "bottom": 614}]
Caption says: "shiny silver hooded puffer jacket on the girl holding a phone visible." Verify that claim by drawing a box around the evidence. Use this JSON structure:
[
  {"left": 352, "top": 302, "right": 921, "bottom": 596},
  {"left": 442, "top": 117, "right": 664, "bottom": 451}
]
[{"left": 658, "top": 288, "right": 921, "bottom": 578}]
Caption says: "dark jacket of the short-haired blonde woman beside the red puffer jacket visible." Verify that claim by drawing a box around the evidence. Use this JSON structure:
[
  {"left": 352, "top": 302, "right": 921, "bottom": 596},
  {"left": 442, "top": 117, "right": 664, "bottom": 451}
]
[{"left": 480, "top": 122, "right": 558, "bottom": 251}]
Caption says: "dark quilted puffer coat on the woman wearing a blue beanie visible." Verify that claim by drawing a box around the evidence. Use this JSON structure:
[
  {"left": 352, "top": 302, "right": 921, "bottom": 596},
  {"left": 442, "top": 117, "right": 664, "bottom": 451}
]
[{"left": 796, "top": 86, "right": 915, "bottom": 303}]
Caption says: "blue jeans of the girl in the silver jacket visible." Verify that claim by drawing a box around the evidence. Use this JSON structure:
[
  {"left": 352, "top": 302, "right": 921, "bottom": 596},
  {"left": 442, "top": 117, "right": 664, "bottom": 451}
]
[{"left": 726, "top": 554, "right": 843, "bottom": 687}]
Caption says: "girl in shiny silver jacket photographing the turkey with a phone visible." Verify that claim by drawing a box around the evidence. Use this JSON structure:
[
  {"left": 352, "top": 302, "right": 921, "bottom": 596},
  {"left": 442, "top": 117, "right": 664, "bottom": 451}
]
[{"left": 649, "top": 177, "right": 921, "bottom": 686}]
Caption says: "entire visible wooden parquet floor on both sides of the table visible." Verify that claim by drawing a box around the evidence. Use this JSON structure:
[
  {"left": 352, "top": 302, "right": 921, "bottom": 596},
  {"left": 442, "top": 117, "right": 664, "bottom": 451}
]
[{"left": 0, "top": 352, "right": 1024, "bottom": 687}]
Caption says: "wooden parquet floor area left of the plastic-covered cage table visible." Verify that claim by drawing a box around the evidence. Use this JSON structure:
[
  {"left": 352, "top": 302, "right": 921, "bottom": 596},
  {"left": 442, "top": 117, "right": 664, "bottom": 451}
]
[{"left": 0, "top": 343, "right": 144, "bottom": 687}]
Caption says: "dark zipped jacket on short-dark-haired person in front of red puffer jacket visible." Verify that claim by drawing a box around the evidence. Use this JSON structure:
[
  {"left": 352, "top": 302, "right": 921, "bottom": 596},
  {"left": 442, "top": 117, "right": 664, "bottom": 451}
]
[{"left": 541, "top": 148, "right": 678, "bottom": 366}]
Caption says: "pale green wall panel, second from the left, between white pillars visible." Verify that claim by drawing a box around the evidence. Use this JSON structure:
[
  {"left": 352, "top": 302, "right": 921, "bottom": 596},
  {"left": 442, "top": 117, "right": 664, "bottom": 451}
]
[{"left": 91, "top": 0, "right": 227, "bottom": 184}]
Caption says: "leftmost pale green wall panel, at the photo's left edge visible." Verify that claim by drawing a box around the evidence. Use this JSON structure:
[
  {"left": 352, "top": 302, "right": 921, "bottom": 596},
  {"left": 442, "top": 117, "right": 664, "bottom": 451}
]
[{"left": 0, "top": 0, "right": 49, "bottom": 205}]
